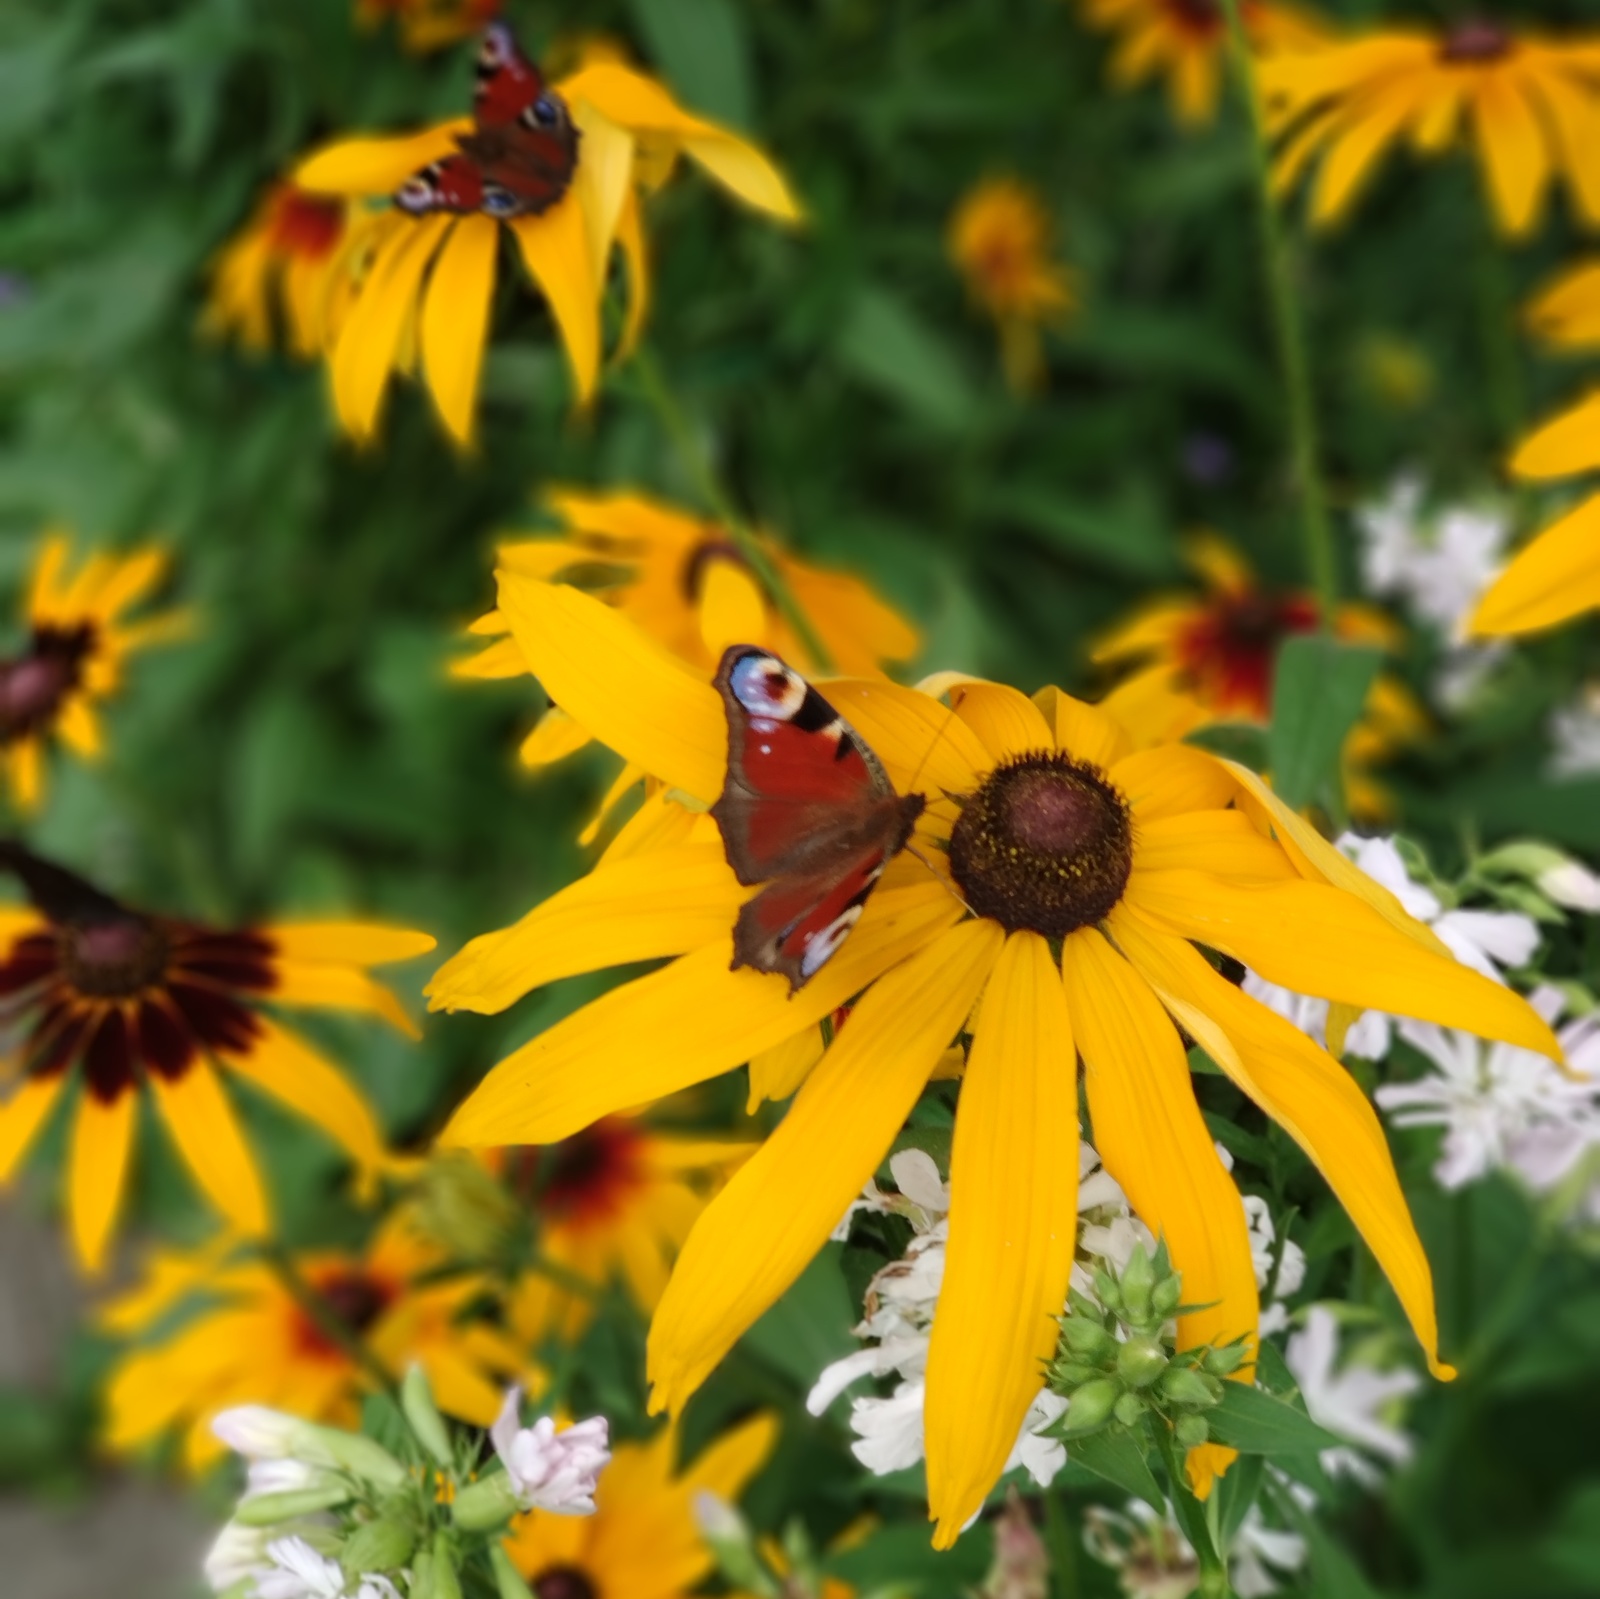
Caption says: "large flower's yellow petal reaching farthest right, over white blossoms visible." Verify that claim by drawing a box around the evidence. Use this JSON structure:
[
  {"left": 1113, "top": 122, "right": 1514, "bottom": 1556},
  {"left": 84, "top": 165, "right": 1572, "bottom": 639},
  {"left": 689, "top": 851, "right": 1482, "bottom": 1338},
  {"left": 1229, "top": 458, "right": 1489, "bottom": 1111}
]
[{"left": 1126, "top": 871, "right": 1563, "bottom": 1061}]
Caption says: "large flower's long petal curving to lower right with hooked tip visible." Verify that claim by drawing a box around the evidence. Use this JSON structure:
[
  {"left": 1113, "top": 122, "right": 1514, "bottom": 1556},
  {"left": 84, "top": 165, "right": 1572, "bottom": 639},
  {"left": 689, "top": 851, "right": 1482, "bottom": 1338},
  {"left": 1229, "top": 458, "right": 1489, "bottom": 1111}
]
[{"left": 1110, "top": 909, "right": 1453, "bottom": 1377}]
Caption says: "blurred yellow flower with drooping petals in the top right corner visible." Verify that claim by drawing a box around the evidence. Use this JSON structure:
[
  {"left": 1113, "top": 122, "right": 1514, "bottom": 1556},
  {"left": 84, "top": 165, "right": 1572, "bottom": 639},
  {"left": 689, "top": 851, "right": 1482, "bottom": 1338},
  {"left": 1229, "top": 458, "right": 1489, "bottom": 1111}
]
[{"left": 1261, "top": 21, "right": 1600, "bottom": 235}]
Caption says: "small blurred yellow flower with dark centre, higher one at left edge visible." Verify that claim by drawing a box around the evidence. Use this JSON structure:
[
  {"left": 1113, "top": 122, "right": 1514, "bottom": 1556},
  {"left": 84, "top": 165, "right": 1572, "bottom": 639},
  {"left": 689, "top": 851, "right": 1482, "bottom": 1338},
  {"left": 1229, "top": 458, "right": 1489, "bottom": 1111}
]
[{"left": 0, "top": 533, "right": 186, "bottom": 810}]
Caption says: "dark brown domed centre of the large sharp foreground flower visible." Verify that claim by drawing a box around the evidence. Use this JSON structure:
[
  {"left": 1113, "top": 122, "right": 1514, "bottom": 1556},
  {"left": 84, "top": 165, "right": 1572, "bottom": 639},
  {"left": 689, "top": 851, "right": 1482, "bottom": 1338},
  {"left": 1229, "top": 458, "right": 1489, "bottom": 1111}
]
[{"left": 950, "top": 751, "right": 1133, "bottom": 938}]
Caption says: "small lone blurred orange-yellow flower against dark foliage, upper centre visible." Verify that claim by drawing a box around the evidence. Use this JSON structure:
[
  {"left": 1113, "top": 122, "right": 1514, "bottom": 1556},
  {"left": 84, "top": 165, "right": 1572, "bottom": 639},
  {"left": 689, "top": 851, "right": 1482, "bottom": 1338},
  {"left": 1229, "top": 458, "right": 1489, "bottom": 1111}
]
[{"left": 946, "top": 178, "right": 1072, "bottom": 394}]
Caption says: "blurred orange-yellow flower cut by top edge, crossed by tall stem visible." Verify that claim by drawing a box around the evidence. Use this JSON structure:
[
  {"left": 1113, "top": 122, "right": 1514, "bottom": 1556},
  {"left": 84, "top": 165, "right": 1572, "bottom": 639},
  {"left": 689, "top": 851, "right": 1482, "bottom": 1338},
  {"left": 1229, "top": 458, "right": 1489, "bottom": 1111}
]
[{"left": 1082, "top": 0, "right": 1325, "bottom": 128}]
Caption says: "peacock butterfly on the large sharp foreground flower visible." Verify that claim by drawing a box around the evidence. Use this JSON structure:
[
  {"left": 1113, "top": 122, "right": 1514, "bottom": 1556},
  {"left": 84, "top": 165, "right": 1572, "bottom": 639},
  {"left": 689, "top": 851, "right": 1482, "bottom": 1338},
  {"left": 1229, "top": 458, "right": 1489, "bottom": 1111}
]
[{"left": 710, "top": 643, "right": 926, "bottom": 994}]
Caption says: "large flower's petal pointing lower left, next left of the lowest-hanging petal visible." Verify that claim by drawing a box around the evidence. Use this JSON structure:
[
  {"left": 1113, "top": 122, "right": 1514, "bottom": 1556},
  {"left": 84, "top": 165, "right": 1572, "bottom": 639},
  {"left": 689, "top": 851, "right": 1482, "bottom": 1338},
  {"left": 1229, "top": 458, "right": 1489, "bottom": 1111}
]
[{"left": 648, "top": 920, "right": 1003, "bottom": 1412}]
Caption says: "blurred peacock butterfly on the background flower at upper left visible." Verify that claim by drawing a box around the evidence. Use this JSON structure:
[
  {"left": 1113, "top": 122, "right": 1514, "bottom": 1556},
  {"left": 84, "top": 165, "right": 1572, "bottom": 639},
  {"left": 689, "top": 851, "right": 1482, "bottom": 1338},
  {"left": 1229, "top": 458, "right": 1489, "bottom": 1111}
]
[{"left": 395, "top": 22, "right": 578, "bottom": 221}]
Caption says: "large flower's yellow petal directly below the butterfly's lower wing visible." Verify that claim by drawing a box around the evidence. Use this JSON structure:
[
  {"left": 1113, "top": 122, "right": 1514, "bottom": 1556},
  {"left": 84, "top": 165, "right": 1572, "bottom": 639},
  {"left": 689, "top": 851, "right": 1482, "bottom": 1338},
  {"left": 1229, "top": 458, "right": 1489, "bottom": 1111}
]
[{"left": 440, "top": 885, "right": 962, "bottom": 1152}]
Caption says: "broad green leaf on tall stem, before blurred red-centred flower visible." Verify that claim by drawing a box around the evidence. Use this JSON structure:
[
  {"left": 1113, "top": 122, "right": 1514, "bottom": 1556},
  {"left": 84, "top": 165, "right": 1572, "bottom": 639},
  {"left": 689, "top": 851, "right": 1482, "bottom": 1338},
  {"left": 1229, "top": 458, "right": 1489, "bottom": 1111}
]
[{"left": 1267, "top": 634, "right": 1381, "bottom": 810}]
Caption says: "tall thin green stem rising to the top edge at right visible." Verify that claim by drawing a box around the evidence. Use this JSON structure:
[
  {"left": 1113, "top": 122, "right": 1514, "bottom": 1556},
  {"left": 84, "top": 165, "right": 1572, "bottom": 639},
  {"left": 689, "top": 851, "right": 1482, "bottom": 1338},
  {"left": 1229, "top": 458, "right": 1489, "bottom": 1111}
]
[{"left": 1222, "top": 0, "right": 1339, "bottom": 632}]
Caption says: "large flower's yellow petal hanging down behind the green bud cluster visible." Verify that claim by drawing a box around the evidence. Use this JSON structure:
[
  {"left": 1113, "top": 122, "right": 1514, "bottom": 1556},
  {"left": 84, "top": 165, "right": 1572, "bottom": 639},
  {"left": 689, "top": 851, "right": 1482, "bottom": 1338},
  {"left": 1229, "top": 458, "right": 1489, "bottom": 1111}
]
[{"left": 1061, "top": 928, "right": 1259, "bottom": 1349}]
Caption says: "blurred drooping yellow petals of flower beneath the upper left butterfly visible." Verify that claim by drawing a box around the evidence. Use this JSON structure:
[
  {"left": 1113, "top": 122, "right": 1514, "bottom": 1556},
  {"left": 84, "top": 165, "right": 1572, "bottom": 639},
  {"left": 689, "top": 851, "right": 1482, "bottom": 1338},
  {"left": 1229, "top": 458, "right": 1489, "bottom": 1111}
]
[{"left": 294, "top": 29, "right": 800, "bottom": 443}]
